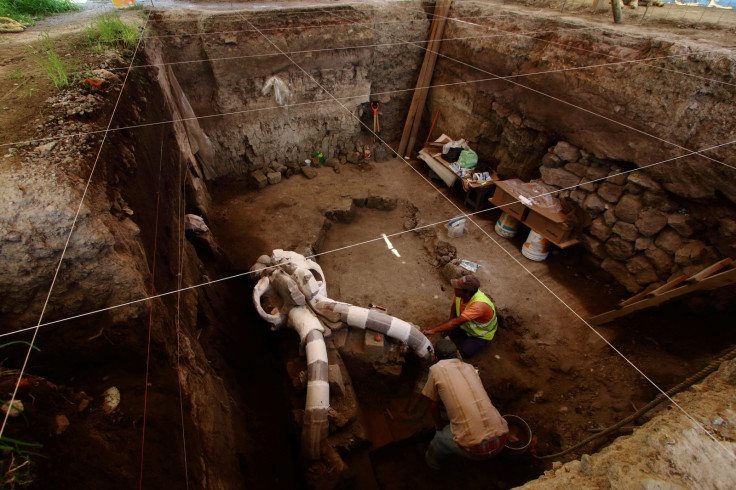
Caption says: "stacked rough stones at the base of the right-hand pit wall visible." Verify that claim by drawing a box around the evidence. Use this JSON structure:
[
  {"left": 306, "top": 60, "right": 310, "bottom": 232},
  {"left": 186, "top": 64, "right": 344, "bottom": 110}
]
[{"left": 539, "top": 141, "right": 736, "bottom": 293}]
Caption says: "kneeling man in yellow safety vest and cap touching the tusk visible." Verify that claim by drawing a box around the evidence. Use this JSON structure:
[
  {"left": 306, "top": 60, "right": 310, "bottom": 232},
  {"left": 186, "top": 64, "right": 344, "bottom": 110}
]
[{"left": 424, "top": 275, "right": 498, "bottom": 359}]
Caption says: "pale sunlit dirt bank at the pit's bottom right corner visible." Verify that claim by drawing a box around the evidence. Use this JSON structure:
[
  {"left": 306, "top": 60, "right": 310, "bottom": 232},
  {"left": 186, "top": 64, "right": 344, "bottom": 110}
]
[{"left": 519, "top": 361, "right": 736, "bottom": 490}]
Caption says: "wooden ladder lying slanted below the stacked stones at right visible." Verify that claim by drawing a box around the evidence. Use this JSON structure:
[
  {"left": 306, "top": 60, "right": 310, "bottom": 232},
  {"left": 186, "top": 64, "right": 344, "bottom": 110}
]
[{"left": 588, "top": 258, "right": 736, "bottom": 325}]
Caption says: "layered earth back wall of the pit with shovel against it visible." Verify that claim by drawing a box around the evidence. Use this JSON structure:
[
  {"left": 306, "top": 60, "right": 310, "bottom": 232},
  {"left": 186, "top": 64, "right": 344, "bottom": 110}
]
[{"left": 147, "top": 5, "right": 429, "bottom": 175}]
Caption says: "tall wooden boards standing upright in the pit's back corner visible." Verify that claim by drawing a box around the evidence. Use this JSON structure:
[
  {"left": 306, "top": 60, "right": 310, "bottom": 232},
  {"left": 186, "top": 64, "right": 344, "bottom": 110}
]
[{"left": 398, "top": 0, "right": 452, "bottom": 157}]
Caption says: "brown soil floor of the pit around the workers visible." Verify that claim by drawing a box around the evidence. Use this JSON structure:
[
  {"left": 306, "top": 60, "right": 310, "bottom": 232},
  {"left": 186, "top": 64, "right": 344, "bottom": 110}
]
[{"left": 211, "top": 153, "right": 734, "bottom": 488}]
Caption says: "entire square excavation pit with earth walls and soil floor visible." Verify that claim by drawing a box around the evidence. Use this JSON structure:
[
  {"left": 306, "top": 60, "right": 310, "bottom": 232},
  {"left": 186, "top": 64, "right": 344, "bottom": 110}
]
[{"left": 0, "top": 2, "right": 736, "bottom": 488}]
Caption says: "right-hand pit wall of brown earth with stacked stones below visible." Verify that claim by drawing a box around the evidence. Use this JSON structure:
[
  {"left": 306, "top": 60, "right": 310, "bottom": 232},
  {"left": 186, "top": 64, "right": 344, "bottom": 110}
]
[{"left": 429, "top": 3, "right": 736, "bottom": 293}]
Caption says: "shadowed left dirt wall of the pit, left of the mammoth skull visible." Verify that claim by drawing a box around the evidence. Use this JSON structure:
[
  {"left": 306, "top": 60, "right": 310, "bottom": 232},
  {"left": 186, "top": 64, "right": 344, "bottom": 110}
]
[{"left": 0, "top": 60, "right": 247, "bottom": 488}]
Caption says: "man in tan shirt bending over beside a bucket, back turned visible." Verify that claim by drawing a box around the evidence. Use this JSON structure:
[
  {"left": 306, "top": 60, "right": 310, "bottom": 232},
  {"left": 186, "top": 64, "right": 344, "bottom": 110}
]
[{"left": 422, "top": 339, "right": 509, "bottom": 470}]
